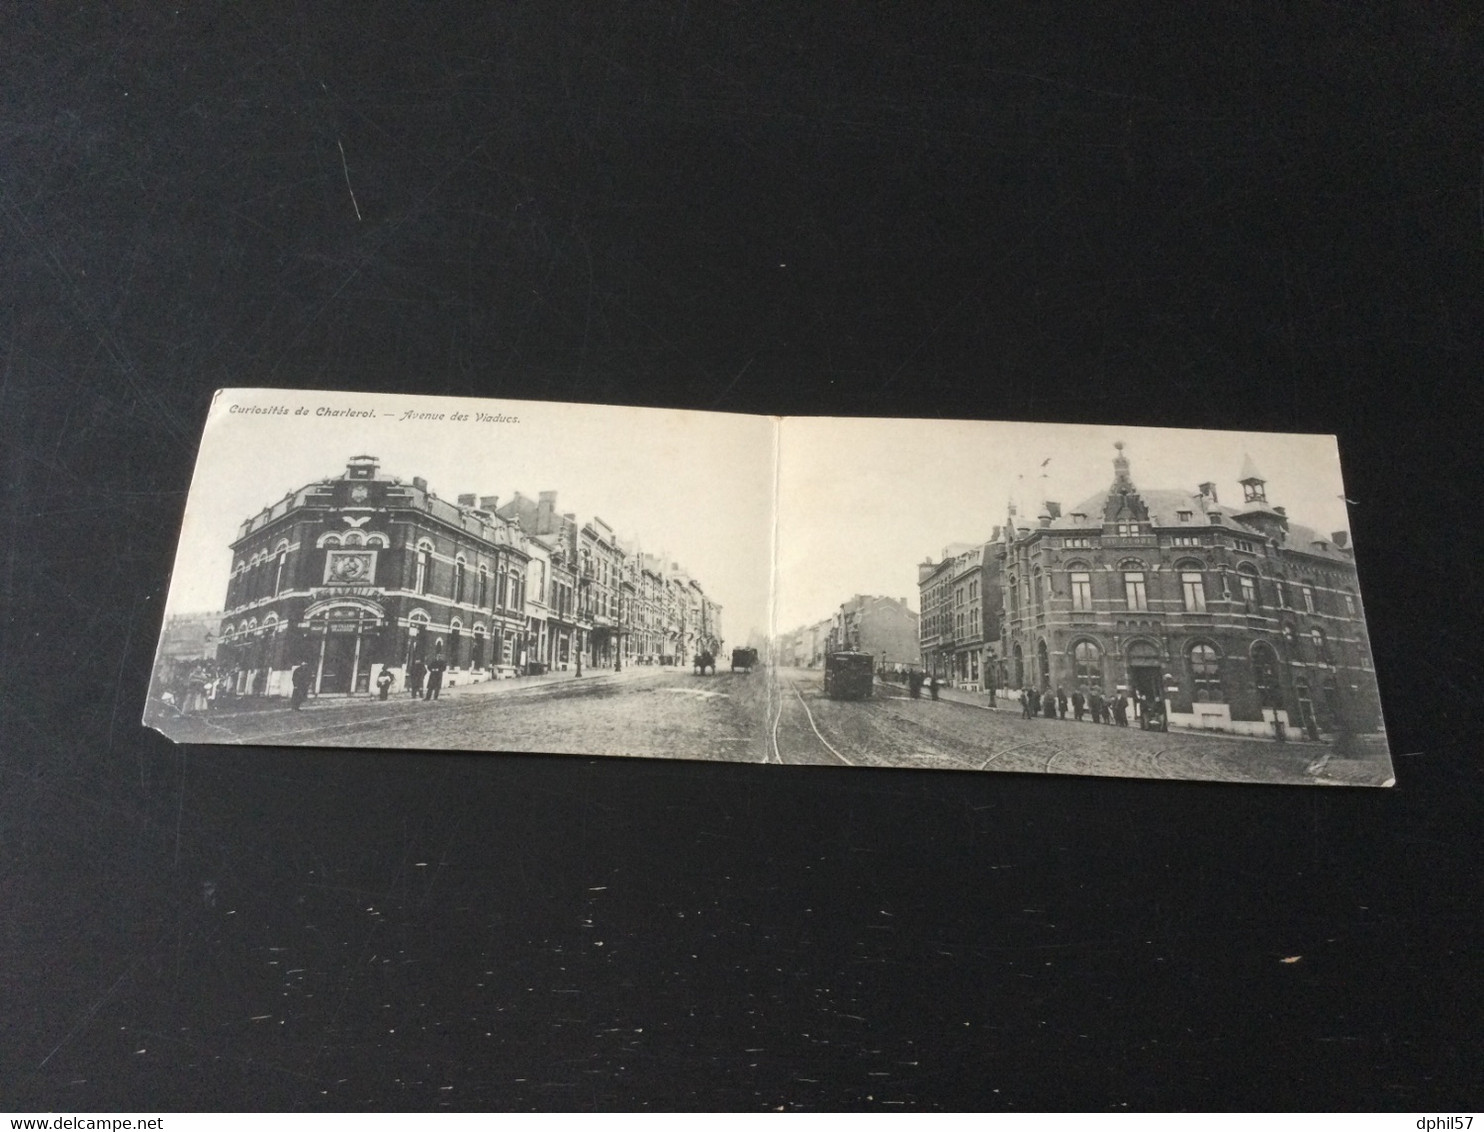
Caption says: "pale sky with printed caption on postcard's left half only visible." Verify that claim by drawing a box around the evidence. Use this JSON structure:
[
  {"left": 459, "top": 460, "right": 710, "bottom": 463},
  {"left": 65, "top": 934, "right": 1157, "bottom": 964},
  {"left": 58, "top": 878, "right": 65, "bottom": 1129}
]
[{"left": 169, "top": 389, "right": 775, "bottom": 644}]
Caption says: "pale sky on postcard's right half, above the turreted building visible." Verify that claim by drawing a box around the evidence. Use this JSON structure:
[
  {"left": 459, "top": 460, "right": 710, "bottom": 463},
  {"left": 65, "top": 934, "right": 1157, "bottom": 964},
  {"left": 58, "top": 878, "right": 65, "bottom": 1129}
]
[{"left": 778, "top": 417, "right": 1349, "bottom": 632}]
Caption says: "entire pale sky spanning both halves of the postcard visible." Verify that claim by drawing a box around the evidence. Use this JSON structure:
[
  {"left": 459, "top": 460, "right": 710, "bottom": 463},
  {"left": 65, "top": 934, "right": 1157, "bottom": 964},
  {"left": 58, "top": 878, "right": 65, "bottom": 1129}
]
[{"left": 169, "top": 390, "right": 1349, "bottom": 644}]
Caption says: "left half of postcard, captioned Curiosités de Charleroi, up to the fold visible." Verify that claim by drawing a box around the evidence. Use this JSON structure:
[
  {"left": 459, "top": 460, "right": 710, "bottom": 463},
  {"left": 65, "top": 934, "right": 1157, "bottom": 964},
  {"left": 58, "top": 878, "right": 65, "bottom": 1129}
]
[{"left": 145, "top": 390, "right": 776, "bottom": 761}]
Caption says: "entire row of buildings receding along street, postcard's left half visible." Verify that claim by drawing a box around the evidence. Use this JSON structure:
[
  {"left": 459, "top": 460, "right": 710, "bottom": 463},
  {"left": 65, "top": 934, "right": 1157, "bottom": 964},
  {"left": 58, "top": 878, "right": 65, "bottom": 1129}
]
[{"left": 200, "top": 455, "right": 721, "bottom": 696}]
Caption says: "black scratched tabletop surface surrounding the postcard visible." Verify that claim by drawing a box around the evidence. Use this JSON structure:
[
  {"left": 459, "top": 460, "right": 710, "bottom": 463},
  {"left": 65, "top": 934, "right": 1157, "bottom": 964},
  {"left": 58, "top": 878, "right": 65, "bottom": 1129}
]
[{"left": 0, "top": 3, "right": 1484, "bottom": 1111}]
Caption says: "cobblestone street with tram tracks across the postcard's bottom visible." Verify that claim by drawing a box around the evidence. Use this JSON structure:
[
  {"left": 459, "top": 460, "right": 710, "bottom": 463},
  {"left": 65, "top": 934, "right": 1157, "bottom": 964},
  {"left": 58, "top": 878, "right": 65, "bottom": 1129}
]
[{"left": 156, "top": 668, "right": 1389, "bottom": 785}]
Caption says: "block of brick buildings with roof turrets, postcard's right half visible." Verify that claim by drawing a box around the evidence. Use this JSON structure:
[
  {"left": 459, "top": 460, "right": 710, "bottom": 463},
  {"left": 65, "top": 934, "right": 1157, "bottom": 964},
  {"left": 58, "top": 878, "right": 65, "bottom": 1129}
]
[{"left": 919, "top": 444, "right": 1380, "bottom": 736}]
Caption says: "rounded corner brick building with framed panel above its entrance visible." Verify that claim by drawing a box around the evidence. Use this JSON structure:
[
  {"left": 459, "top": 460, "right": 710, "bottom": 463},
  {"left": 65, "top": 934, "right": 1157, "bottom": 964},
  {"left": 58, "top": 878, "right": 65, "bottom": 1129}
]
[{"left": 217, "top": 455, "right": 531, "bottom": 694}]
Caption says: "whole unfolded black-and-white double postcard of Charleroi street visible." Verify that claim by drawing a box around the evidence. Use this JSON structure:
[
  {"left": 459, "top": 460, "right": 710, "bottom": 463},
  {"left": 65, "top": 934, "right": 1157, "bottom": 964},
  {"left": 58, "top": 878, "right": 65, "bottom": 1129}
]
[{"left": 144, "top": 389, "right": 1393, "bottom": 786}]
